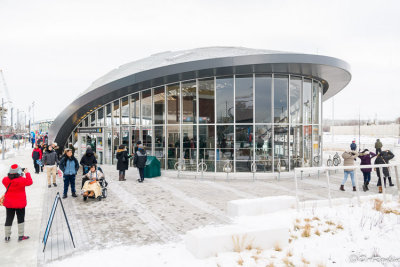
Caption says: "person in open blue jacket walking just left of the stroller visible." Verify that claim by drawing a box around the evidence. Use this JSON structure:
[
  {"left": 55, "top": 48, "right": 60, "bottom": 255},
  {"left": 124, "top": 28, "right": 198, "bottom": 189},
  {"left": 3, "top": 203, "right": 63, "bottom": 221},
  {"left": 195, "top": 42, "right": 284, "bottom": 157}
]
[{"left": 60, "top": 148, "right": 79, "bottom": 198}]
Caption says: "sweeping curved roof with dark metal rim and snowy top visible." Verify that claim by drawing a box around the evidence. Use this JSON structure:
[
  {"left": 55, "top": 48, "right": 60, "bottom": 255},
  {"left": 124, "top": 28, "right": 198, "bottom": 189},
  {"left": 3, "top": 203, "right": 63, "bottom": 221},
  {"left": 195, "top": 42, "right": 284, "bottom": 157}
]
[{"left": 49, "top": 47, "right": 351, "bottom": 145}]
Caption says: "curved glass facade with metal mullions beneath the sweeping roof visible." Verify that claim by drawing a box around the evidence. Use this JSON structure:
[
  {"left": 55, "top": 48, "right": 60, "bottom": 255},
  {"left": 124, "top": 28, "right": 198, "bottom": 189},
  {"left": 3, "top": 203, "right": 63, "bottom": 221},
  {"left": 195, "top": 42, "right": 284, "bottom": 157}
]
[{"left": 69, "top": 73, "right": 323, "bottom": 173}]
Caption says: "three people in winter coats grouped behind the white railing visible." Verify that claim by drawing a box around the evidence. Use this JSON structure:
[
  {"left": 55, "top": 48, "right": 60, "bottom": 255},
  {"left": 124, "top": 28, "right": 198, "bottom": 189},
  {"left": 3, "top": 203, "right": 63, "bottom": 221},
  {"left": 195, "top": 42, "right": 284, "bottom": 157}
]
[{"left": 340, "top": 139, "right": 394, "bottom": 193}]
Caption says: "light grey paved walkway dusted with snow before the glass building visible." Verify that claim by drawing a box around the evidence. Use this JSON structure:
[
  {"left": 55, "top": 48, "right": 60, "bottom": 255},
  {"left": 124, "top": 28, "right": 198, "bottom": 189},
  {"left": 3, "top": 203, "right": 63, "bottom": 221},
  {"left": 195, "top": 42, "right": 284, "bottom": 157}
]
[{"left": 0, "top": 151, "right": 395, "bottom": 266}]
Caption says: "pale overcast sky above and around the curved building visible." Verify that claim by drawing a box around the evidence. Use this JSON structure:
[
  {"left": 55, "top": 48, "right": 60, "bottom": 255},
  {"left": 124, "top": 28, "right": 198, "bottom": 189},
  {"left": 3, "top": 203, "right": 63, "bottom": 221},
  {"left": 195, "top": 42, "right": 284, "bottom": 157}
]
[{"left": 0, "top": 0, "right": 400, "bottom": 120}]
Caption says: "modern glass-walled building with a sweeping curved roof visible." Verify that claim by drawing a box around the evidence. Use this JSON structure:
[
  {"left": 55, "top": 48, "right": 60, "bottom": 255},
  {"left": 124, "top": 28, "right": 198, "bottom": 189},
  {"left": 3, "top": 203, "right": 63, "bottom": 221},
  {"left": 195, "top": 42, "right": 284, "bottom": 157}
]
[{"left": 49, "top": 47, "right": 351, "bottom": 172}]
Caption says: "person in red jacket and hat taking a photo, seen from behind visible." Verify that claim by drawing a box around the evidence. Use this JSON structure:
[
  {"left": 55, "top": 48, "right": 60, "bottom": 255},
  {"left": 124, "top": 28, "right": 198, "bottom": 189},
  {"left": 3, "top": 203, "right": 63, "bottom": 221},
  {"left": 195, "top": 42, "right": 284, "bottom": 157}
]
[{"left": 3, "top": 164, "right": 33, "bottom": 242}]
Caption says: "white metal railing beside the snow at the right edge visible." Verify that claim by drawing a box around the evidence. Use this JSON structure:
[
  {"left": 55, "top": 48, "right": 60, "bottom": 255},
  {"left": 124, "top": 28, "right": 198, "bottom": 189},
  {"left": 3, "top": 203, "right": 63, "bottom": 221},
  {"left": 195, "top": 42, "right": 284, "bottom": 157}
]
[{"left": 294, "top": 163, "right": 400, "bottom": 210}]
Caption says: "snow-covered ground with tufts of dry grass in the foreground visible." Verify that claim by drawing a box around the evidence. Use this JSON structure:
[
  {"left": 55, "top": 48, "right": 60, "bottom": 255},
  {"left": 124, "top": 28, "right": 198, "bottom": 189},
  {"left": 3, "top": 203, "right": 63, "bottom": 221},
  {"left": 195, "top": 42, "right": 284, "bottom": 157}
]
[{"left": 49, "top": 196, "right": 400, "bottom": 267}]
